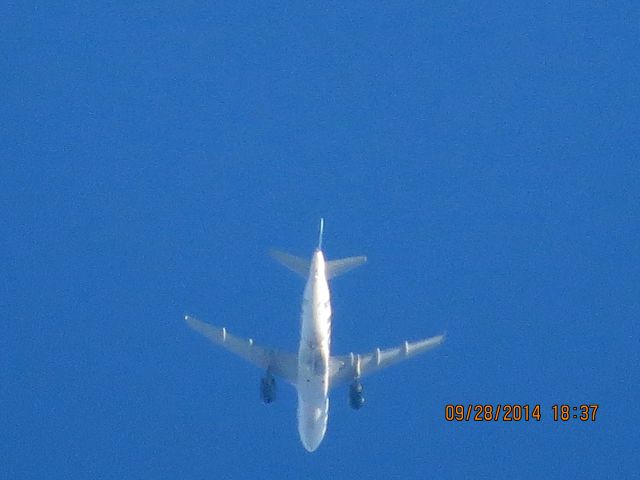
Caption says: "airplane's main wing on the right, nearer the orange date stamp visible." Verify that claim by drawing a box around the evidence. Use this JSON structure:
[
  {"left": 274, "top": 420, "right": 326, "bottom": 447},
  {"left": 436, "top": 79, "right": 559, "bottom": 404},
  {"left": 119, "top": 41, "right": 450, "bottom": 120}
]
[{"left": 329, "top": 335, "right": 445, "bottom": 387}]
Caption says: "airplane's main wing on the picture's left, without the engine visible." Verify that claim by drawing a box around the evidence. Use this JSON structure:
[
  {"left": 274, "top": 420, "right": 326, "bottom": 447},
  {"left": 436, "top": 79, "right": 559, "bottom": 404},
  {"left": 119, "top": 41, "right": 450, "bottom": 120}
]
[{"left": 184, "top": 315, "right": 298, "bottom": 385}]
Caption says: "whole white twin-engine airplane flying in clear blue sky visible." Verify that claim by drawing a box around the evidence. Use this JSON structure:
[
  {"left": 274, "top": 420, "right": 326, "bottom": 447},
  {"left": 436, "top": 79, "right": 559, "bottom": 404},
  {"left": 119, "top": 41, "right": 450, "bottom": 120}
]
[{"left": 184, "top": 219, "right": 445, "bottom": 452}]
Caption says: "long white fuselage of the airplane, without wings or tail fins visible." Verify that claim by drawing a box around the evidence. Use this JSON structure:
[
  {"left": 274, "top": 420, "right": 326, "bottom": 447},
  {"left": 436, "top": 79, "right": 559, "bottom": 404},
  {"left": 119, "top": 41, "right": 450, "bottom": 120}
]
[{"left": 297, "top": 249, "right": 331, "bottom": 452}]
